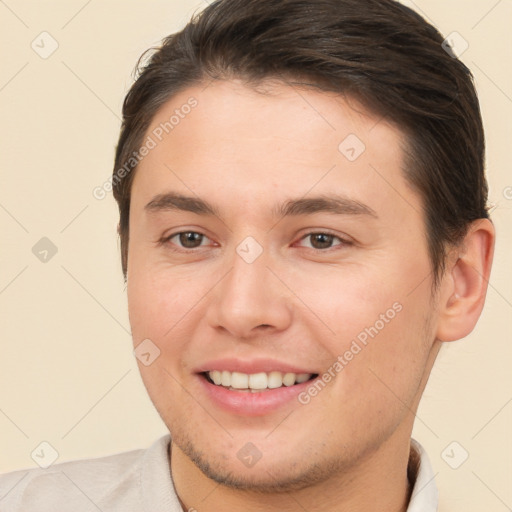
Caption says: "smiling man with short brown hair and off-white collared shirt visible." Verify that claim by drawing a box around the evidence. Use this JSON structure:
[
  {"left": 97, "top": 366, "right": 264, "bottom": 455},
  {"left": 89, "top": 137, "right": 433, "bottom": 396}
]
[{"left": 1, "top": 0, "right": 494, "bottom": 512}]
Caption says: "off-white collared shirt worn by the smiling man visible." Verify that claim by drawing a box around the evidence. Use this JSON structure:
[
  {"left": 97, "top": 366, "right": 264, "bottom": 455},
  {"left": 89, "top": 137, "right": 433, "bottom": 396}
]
[{"left": 0, "top": 435, "right": 438, "bottom": 512}]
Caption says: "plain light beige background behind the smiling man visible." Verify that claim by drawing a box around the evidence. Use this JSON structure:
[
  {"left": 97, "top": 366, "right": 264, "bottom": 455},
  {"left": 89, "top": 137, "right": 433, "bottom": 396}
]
[{"left": 0, "top": 0, "right": 512, "bottom": 512}]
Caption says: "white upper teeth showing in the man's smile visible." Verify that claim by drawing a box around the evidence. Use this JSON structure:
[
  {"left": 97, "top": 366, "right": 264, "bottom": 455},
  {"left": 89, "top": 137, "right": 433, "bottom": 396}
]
[{"left": 208, "top": 370, "right": 313, "bottom": 389}]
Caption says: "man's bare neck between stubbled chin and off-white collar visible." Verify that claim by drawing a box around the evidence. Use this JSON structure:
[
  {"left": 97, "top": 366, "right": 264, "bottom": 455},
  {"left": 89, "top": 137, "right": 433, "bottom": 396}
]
[{"left": 171, "top": 432, "right": 417, "bottom": 512}]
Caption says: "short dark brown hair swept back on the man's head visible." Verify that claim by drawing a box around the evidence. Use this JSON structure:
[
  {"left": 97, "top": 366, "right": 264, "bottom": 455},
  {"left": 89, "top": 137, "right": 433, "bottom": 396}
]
[{"left": 113, "top": 0, "right": 488, "bottom": 283}]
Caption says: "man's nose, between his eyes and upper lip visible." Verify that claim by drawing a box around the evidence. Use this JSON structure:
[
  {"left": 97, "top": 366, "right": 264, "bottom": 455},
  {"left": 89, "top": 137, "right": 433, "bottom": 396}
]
[{"left": 207, "top": 249, "right": 292, "bottom": 339}]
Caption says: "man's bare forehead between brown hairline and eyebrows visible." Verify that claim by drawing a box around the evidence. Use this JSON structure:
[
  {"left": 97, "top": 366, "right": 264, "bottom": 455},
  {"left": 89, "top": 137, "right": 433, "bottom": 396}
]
[{"left": 132, "top": 81, "right": 418, "bottom": 220}]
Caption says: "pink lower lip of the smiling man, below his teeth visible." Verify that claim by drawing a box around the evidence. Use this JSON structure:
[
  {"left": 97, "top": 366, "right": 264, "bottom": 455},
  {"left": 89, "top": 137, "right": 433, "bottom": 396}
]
[{"left": 199, "top": 374, "right": 318, "bottom": 416}]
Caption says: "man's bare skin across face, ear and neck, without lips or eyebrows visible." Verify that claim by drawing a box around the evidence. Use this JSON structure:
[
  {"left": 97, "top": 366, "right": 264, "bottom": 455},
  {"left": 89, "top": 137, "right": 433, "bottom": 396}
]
[{"left": 128, "top": 81, "right": 493, "bottom": 512}]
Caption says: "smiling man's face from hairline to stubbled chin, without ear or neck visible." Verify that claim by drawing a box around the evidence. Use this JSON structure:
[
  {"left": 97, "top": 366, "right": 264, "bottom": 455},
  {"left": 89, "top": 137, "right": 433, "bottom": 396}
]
[{"left": 128, "top": 82, "right": 437, "bottom": 489}]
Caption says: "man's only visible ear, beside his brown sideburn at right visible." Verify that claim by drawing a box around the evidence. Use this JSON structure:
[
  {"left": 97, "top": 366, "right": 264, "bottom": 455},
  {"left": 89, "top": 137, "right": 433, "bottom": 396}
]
[{"left": 436, "top": 219, "right": 495, "bottom": 341}]
